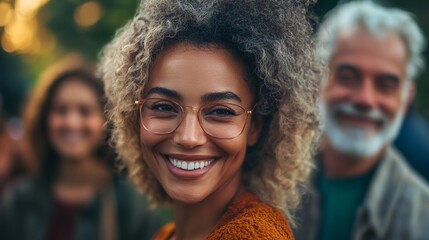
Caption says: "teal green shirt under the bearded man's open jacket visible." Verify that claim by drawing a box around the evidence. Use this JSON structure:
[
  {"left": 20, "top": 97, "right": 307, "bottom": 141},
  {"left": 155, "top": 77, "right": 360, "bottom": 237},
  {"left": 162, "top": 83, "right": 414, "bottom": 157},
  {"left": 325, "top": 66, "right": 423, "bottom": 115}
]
[{"left": 318, "top": 170, "right": 374, "bottom": 240}]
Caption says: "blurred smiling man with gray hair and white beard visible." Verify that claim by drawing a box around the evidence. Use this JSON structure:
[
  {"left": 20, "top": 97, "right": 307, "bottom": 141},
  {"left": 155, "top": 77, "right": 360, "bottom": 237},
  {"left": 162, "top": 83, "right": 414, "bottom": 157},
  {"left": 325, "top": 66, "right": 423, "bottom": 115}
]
[{"left": 295, "top": 1, "right": 429, "bottom": 240}]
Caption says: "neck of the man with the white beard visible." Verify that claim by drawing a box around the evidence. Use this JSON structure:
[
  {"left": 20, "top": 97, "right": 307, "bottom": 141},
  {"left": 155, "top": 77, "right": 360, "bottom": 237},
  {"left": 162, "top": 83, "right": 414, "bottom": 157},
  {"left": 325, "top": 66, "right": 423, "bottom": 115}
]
[{"left": 321, "top": 138, "right": 387, "bottom": 178}]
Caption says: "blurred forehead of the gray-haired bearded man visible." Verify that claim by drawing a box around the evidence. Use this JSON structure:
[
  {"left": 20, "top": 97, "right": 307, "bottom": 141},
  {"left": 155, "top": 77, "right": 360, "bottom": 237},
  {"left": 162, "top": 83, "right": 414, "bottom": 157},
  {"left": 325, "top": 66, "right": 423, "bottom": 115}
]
[{"left": 330, "top": 29, "right": 408, "bottom": 78}]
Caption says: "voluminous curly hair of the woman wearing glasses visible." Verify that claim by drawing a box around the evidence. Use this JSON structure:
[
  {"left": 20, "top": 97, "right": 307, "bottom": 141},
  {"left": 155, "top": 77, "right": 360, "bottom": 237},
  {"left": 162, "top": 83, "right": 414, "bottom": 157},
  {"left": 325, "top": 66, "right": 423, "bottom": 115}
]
[{"left": 100, "top": 0, "right": 320, "bottom": 224}]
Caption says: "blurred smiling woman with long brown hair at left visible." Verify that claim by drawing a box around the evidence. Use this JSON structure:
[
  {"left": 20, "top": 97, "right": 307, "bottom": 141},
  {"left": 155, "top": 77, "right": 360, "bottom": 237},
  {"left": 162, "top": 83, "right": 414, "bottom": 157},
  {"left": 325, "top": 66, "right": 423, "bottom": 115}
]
[{"left": 0, "top": 55, "right": 169, "bottom": 240}]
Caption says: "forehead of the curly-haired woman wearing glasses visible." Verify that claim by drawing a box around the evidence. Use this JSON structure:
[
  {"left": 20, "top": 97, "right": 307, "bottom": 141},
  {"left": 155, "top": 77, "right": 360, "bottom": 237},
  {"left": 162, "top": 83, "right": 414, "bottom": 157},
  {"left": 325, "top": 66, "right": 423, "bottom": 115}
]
[{"left": 145, "top": 43, "right": 250, "bottom": 103}]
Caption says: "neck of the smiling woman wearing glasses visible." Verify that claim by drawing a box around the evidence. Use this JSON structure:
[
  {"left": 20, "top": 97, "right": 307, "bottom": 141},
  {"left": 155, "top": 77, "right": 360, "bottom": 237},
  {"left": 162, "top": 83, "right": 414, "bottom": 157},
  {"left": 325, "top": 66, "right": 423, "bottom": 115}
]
[{"left": 173, "top": 174, "right": 245, "bottom": 240}]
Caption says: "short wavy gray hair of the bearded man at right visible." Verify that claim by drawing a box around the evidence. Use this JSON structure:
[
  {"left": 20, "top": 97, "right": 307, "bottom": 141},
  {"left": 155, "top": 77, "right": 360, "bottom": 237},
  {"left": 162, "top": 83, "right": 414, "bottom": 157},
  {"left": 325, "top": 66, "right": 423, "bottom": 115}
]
[{"left": 316, "top": 1, "right": 426, "bottom": 80}]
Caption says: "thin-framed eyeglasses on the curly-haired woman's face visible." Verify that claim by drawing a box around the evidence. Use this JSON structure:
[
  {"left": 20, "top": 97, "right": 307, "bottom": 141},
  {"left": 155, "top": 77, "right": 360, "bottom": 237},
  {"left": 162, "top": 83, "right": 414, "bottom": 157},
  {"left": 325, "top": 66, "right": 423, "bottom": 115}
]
[{"left": 135, "top": 98, "right": 253, "bottom": 139}]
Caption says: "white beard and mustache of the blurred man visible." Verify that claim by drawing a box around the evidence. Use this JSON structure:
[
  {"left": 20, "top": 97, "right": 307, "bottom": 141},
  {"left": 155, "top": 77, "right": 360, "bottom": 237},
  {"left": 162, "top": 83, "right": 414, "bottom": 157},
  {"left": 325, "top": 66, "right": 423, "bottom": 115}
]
[{"left": 320, "top": 101, "right": 405, "bottom": 158}]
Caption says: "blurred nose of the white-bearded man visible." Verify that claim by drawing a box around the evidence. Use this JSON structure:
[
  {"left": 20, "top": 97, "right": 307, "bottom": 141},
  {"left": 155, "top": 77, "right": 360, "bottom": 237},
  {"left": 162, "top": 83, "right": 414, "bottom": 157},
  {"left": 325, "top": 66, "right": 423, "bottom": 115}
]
[{"left": 352, "top": 79, "right": 377, "bottom": 110}]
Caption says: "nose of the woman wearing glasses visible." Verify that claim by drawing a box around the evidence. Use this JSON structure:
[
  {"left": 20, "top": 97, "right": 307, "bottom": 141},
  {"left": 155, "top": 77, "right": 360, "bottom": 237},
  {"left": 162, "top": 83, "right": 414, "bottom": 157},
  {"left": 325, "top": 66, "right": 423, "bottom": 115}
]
[{"left": 174, "top": 111, "right": 207, "bottom": 149}]
